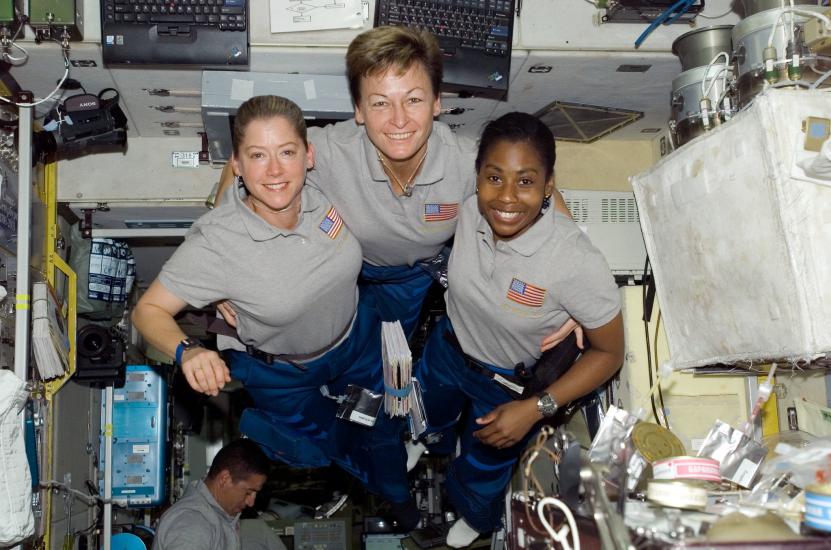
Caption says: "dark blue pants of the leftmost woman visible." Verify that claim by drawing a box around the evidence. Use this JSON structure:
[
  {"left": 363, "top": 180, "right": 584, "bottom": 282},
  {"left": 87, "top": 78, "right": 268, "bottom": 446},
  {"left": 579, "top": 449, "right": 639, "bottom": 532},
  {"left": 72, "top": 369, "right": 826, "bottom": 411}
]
[{"left": 230, "top": 303, "right": 409, "bottom": 503}]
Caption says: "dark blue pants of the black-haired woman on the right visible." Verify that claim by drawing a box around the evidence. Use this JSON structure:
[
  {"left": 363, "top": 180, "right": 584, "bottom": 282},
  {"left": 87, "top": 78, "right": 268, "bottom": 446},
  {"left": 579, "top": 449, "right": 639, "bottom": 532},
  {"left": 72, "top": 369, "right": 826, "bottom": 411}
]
[{"left": 416, "top": 317, "right": 536, "bottom": 533}]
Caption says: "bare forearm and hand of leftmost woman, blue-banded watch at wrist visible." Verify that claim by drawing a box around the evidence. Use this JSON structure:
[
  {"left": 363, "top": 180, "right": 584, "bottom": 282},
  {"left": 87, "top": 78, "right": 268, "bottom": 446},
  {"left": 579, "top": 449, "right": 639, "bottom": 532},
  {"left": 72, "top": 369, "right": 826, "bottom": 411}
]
[{"left": 131, "top": 279, "right": 231, "bottom": 395}]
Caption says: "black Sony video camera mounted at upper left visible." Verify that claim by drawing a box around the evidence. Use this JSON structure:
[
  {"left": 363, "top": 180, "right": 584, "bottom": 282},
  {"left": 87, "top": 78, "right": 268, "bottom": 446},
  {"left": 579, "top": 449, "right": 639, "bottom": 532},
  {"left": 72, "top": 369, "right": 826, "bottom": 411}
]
[{"left": 32, "top": 88, "right": 127, "bottom": 163}]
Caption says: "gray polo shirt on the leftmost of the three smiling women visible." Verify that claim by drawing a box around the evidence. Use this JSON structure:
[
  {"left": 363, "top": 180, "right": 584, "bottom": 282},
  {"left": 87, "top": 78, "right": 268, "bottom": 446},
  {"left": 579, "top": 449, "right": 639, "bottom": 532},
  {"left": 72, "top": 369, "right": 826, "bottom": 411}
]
[{"left": 159, "top": 185, "right": 361, "bottom": 354}]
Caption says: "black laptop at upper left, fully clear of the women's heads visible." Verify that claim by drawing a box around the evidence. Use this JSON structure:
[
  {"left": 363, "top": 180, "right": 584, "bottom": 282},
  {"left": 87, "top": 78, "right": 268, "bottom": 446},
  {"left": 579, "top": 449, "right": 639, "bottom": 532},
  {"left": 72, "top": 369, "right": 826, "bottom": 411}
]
[{"left": 101, "top": 0, "right": 248, "bottom": 67}]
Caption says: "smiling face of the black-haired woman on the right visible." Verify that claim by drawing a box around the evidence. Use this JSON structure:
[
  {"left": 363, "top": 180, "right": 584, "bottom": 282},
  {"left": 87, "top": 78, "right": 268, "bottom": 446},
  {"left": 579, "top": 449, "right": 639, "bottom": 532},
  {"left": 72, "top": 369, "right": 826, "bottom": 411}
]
[{"left": 476, "top": 139, "right": 554, "bottom": 241}]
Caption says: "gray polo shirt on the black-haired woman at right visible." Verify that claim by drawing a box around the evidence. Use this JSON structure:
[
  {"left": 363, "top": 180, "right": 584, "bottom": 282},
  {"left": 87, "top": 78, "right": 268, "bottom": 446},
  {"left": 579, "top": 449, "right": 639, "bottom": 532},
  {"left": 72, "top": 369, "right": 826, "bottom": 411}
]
[{"left": 445, "top": 197, "right": 620, "bottom": 368}]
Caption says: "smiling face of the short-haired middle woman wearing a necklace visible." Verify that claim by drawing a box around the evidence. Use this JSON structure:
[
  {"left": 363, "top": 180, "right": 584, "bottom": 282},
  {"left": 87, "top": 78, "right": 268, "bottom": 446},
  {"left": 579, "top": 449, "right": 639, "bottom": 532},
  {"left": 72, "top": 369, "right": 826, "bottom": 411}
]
[{"left": 355, "top": 63, "right": 441, "bottom": 168}]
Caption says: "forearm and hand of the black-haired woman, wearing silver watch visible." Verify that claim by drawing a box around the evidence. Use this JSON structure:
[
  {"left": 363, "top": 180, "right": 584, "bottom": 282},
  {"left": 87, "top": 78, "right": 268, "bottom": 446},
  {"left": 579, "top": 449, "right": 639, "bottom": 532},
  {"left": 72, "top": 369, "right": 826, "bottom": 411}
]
[{"left": 473, "top": 313, "right": 624, "bottom": 448}]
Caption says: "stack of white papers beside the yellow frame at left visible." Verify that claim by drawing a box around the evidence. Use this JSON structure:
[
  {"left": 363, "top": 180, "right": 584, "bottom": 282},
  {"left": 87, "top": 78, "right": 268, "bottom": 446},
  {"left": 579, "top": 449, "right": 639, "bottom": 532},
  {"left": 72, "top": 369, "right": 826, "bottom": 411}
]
[{"left": 32, "top": 283, "right": 69, "bottom": 380}]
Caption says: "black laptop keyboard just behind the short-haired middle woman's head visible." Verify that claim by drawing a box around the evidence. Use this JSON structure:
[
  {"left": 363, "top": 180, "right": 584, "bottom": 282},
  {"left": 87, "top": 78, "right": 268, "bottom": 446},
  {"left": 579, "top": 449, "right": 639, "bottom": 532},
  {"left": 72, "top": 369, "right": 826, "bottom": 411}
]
[{"left": 376, "top": 0, "right": 513, "bottom": 56}]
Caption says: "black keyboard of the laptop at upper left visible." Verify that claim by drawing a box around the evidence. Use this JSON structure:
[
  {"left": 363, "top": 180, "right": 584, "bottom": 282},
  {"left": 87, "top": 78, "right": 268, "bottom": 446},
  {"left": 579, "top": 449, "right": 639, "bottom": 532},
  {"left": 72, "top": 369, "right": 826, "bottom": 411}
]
[{"left": 102, "top": 0, "right": 247, "bottom": 31}]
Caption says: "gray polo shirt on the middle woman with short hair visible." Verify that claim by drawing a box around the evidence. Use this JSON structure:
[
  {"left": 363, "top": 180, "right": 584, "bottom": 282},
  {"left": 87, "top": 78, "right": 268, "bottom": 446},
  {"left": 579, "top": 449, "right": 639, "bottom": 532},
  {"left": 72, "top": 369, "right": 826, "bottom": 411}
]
[{"left": 308, "top": 120, "right": 476, "bottom": 266}]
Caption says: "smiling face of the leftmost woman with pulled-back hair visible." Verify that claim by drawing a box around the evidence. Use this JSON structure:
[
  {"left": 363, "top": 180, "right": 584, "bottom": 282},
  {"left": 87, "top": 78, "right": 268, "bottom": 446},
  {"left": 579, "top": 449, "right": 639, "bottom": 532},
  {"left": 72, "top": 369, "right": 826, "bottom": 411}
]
[{"left": 231, "top": 116, "right": 314, "bottom": 222}]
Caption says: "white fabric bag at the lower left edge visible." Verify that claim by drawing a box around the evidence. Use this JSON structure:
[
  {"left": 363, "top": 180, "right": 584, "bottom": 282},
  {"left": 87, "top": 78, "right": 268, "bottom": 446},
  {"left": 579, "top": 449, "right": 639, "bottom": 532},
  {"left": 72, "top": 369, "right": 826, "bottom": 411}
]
[{"left": 0, "top": 369, "right": 35, "bottom": 546}]
